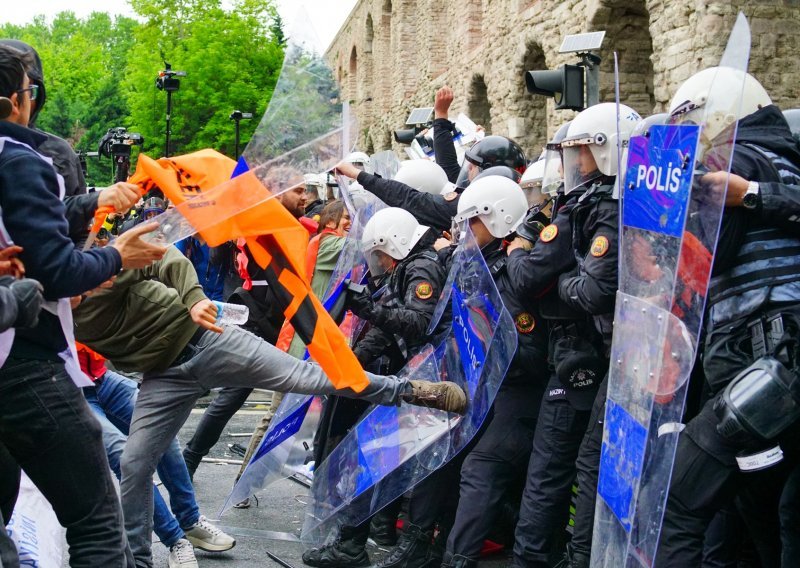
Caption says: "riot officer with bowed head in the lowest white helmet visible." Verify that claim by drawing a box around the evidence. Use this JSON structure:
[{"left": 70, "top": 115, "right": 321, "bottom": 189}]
[{"left": 303, "top": 207, "right": 445, "bottom": 567}]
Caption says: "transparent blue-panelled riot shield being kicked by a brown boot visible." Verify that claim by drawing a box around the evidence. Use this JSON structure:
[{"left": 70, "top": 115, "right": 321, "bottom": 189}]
[{"left": 301, "top": 228, "right": 517, "bottom": 543}]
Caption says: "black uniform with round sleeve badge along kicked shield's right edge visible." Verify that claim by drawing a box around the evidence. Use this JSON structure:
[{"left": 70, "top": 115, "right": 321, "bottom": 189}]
[{"left": 443, "top": 239, "right": 548, "bottom": 566}]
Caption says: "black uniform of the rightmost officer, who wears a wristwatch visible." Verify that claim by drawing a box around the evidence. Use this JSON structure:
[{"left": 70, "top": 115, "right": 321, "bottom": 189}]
[{"left": 656, "top": 105, "right": 800, "bottom": 567}]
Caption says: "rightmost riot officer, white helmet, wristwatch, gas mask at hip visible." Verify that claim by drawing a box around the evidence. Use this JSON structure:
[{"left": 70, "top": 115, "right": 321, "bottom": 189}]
[{"left": 656, "top": 68, "right": 800, "bottom": 567}]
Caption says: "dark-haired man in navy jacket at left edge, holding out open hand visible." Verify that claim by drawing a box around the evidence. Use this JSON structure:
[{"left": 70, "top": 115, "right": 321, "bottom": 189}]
[{"left": 0, "top": 42, "right": 165, "bottom": 568}]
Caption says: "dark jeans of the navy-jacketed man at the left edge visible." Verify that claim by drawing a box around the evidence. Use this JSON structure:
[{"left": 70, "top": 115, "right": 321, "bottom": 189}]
[{"left": 0, "top": 359, "right": 133, "bottom": 568}]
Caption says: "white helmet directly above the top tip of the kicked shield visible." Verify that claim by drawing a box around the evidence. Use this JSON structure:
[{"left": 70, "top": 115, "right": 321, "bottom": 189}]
[{"left": 455, "top": 176, "right": 528, "bottom": 239}]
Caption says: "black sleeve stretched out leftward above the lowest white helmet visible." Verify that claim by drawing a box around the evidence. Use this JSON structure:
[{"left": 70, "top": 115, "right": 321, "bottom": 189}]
[{"left": 357, "top": 172, "right": 458, "bottom": 231}]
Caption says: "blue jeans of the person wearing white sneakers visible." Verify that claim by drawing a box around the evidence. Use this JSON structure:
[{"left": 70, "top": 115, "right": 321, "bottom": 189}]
[{"left": 83, "top": 371, "right": 200, "bottom": 548}]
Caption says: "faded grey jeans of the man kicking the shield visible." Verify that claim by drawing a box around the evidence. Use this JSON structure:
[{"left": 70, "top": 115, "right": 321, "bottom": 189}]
[{"left": 120, "top": 327, "right": 409, "bottom": 567}]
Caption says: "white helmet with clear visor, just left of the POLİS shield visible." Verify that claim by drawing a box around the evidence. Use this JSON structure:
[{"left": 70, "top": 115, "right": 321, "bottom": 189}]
[{"left": 561, "top": 103, "right": 642, "bottom": 195}]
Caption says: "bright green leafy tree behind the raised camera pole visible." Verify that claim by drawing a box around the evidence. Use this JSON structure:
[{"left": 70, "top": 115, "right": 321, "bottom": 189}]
[{"left": 125, "top": 0, "right": 283, "bottom": 156}]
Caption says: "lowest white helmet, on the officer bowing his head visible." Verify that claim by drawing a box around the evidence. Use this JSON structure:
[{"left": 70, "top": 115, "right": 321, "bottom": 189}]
[{"left": 361, "top": 207, "right": 428, "bottom": 276}]
